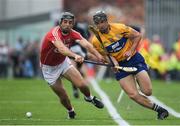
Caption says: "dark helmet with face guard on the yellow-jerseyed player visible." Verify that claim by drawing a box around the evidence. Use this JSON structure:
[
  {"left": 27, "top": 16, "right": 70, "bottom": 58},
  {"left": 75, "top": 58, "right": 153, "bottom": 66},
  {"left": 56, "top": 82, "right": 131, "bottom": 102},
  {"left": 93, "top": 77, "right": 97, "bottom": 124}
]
[{"left": 93, "top": 11, "right": 107, "bottom": 24}]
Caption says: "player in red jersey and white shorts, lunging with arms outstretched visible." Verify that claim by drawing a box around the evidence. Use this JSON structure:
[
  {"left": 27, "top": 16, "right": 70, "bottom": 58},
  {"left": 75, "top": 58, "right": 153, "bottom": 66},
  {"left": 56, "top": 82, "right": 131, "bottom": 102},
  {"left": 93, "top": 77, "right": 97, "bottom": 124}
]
[{"left": 40, "top": 12, "right": 104, "bottom": 119}]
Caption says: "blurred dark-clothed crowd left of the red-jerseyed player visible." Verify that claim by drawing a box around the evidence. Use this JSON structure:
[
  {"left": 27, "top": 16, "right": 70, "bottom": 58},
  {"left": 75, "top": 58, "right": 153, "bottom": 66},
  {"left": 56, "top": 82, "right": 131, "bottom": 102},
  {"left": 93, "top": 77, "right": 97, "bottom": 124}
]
[{"left": 0, "top": 37, "right": 40, "bottom": 78}]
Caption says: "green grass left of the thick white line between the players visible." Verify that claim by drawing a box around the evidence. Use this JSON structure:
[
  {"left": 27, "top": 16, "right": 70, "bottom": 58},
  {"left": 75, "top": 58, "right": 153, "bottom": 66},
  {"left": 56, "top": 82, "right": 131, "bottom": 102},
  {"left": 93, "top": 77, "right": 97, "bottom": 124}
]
[{"left": 0, "top": 80, "right": 115, "bottom": 125}]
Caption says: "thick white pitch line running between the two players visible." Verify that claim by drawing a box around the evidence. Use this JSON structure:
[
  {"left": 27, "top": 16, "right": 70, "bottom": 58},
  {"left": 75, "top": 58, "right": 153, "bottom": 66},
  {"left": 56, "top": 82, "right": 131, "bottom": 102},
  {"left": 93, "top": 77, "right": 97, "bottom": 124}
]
[{"left": 88, "top": 78, "right": 129, "bottom": 126}]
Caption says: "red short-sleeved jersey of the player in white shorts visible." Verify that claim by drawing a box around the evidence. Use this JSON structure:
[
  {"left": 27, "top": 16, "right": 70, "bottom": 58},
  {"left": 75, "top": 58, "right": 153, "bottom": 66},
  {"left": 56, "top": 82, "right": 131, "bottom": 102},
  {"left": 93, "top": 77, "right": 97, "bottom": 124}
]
[{"left": 40, "top": 26, "right": 83, "bottom": 66}]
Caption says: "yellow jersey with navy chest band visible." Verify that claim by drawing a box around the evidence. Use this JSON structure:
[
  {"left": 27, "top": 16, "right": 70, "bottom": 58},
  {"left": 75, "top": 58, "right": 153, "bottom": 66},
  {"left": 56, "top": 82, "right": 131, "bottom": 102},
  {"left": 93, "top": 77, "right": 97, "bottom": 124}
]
[{"left": 91, "top": 23, "right": 135, "bottom": 62}]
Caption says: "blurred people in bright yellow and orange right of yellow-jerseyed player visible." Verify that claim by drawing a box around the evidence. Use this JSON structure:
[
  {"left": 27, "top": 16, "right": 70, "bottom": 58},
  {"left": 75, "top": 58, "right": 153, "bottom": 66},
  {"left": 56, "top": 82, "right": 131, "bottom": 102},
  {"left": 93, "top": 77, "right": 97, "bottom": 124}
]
[{"left": 139, "top": 33, "right": 180, "bottom": 81}]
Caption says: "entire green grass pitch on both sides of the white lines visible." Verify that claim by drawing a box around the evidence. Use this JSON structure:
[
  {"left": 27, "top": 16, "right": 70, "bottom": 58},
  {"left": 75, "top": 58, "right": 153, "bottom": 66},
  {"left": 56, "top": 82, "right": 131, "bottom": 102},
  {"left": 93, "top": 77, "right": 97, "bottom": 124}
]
[{"left": 0, "top": 79, "right": 180, "bottom": 125}]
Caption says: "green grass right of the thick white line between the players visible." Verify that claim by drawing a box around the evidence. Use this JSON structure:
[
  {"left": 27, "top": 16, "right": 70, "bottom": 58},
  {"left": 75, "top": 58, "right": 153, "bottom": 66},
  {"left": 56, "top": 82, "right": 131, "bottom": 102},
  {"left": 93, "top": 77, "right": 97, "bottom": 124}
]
[{"left": 101, "top": 80, "right": 180, "bottom": 125}]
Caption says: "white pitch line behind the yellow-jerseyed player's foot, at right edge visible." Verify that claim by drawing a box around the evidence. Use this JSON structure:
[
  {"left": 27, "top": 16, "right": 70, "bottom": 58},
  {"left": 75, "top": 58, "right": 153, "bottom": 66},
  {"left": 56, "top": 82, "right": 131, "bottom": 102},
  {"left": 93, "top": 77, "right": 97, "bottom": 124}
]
[{"left": 148, "top": 96, "right": 180, "bottom": 118}]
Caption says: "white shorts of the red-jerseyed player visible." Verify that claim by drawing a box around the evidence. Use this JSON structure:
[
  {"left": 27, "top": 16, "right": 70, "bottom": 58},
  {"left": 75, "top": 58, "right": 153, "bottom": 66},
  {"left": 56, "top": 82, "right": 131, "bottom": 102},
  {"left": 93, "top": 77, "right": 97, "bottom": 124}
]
[{"left": 41, "top": 57, "right": 73, "bottom": 85}]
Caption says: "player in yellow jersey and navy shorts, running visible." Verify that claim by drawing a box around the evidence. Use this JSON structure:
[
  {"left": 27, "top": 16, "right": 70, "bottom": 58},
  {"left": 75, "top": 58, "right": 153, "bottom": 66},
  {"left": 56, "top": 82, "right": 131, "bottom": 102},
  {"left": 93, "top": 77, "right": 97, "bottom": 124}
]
[{"left": 92, "top": 11, "right": 169, "bottom": 120}]
